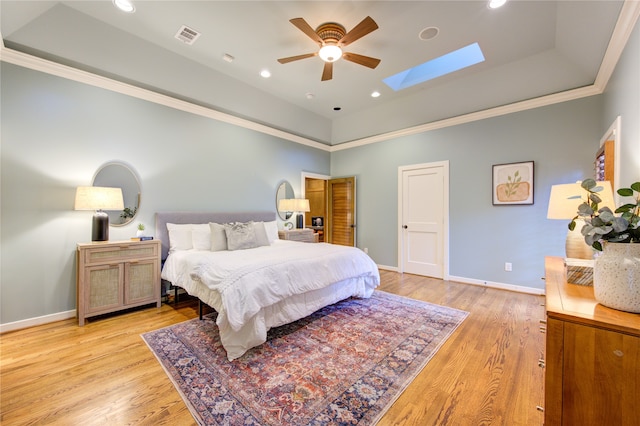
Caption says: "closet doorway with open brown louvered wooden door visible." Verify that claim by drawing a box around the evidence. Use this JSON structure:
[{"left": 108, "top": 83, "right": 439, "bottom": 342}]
[{"left": 302, "top": 173, "right": 356, "bottom": 246}]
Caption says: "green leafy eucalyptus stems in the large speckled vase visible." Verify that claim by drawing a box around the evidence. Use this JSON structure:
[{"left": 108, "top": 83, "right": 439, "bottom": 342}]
[{"left": 569, "top": 179, "right": 640, "bottom": 251}]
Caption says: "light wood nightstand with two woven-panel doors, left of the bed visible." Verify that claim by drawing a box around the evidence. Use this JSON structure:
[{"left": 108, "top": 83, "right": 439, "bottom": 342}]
[{"left": 76, "top": 240, "right": 162, "bottom": 326}]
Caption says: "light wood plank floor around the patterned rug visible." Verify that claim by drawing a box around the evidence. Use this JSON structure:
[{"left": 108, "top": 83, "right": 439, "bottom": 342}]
[{"left": 0, "top": 271, "right": 544, "bottom": 426}]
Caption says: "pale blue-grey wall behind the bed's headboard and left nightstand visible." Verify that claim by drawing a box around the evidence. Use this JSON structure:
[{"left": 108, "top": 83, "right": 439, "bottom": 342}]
[{"left": 0, "top": 63, "right": 329, "bottom": 324}]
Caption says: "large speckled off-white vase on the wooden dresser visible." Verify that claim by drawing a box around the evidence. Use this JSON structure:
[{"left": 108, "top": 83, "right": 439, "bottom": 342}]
[{"left": 593, "top": 243, "right": 640, "bottom": 313}]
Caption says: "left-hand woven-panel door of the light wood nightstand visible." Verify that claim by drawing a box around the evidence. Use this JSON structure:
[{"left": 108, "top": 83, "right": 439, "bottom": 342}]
[{"left": 84, "top": 264, "right": 122, "bottom": 314}]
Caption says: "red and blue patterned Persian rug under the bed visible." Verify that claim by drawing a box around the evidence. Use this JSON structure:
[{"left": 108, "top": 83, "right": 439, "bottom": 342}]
[{"left": 142, "top": 291, "right": 468, "bottom": 426}]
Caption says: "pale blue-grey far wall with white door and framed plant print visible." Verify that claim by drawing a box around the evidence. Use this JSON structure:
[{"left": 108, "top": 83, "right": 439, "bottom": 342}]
[{"left": 331, "top": 97, "right": 602, "bottom": 288}]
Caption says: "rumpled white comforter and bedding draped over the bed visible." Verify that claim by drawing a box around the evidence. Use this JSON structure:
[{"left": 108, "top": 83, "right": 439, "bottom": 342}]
[{"left": 162, "top": 240, "right": 380, "bottom": 360}]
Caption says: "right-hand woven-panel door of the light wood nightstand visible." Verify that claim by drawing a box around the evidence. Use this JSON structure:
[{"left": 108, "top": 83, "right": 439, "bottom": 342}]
[{"left": 124, "top": 259, "right": 160, "bottom": 305}]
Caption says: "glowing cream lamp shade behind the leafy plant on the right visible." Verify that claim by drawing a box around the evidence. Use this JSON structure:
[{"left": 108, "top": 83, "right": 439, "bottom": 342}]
[{"left": 547, "top": 181, "right": 615, "bottom": 220}]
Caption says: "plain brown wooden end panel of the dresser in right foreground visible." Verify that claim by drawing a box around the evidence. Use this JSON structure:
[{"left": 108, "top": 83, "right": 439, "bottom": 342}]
[{"left": 562, "top": 323, "right": 640, "bottom": 425}]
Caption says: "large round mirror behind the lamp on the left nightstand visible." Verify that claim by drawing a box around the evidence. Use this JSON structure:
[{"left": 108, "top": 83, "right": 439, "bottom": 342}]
[{"left": 93, "top": 162, "right": 140, "bottom": 226}]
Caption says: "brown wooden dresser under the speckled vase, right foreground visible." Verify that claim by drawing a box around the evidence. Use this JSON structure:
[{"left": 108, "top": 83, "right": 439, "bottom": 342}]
[{"left": 540, "top": 257, "right": 640, "bottom": 426}]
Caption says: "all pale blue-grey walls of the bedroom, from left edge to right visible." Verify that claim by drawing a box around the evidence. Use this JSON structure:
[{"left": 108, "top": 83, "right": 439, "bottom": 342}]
[{"left": 0, "top": 15, "right": 640, "bottom": 324}]
